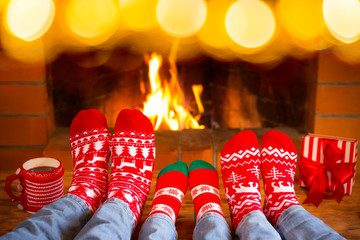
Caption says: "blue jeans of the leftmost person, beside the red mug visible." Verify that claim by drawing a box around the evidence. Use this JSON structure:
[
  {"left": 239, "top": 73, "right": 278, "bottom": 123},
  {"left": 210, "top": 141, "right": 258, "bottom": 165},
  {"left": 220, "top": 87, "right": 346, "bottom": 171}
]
[{"left": 1, "top": 194, "right": 135, "bottom": 240}]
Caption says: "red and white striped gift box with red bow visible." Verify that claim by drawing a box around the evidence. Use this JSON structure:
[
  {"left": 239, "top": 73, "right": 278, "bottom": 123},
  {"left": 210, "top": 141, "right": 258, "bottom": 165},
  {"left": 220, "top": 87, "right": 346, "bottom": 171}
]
[{"left": 298, "top": 134, "right": 358, "bottom": 206}]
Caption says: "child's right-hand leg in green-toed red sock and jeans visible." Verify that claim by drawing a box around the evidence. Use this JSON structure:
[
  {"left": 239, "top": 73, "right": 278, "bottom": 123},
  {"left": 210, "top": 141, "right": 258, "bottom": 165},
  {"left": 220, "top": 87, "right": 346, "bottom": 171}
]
[{"left": 189, "top": 160, "right": 231, "bottom": 239}]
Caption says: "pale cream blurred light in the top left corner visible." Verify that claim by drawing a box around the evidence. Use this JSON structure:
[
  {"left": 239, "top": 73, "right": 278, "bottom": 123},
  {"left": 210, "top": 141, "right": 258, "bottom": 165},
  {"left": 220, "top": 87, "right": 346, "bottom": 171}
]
[{"left": 5, "top": 0, "right": 55, "bottom": 41}]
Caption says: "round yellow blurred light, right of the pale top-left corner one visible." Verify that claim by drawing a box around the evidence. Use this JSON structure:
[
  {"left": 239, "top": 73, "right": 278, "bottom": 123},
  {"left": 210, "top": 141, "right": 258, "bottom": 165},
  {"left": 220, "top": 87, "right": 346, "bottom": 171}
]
[{"left": 66, "top": 0, "right": 118, "bottom": 45}]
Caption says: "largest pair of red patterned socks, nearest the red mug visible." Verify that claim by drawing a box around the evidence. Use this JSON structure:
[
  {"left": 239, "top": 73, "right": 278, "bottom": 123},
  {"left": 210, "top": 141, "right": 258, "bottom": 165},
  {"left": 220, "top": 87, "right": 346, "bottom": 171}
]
[{"left": 68, "top": 109, "right": 155, "bottom": 224}]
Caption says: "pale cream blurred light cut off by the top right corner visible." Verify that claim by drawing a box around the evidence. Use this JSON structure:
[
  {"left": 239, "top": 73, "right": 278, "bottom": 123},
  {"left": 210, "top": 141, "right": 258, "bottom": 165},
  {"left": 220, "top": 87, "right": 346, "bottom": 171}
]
[{"left": 323, "top": 0, "right": 360, "bottom": 43}]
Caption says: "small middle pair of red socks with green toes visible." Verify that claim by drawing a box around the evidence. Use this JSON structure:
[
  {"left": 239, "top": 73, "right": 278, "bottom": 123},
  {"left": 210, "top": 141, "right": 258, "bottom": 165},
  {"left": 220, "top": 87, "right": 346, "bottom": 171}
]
[{"left": 149, "top": 160, "right": 223, "bottom": 223}]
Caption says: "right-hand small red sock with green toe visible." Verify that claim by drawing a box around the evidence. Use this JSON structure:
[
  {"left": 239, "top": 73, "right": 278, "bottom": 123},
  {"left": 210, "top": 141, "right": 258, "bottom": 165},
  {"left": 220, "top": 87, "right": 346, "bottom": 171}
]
[{"left": 189, "top": 160, "right": 224, "bottom": 223}]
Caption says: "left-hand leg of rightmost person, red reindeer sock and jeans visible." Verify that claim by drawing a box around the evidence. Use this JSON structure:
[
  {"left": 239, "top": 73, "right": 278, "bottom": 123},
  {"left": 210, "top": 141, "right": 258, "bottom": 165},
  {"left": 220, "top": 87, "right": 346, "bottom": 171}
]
[{"left": 221, "top": 131, "right": 280, "bottom": 239}]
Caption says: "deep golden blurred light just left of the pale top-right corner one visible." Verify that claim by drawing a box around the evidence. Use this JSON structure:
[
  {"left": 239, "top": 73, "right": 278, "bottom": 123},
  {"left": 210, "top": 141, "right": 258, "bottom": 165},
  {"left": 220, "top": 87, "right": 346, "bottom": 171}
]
[{"left": 278, "top": 0, "right": 324, "bottom": 40}]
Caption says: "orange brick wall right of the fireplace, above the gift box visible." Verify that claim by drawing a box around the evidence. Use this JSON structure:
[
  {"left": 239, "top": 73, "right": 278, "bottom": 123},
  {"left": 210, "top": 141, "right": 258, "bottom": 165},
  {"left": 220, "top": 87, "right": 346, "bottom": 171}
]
[{"left": 314, "top": 53, "right": 360, "bottom": 139}]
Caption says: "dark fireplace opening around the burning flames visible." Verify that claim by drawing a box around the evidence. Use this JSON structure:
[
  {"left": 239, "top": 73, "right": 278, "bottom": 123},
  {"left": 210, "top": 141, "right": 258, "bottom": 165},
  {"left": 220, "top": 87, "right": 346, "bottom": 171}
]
[{"left": 48, "top": 48, "right": 317, "bottom": 132}]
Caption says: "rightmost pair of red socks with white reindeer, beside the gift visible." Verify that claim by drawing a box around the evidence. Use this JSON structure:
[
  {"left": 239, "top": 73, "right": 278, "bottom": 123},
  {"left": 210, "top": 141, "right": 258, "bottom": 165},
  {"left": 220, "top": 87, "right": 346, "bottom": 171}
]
[{"left": 221, "top": 130, "right": 299, "bottom": 229}]
